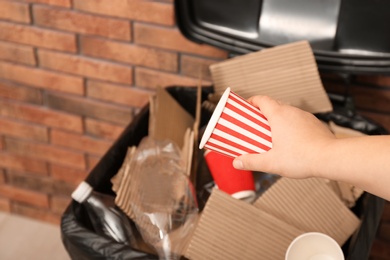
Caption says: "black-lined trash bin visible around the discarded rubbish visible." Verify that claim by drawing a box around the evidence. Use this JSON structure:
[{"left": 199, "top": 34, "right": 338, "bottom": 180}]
[{"left": 61, "top": 86, "right": 387, "bottom": 260}]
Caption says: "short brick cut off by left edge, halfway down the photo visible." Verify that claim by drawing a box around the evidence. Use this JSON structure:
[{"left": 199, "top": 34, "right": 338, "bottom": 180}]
[{"left": 0, "top": 117, "right": 49, "bottom": 142}]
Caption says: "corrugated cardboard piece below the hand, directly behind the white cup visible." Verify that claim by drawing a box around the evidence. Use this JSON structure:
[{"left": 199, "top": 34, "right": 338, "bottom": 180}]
[{"left": 253, "top": 178, "right": 360, "bottom": 245}]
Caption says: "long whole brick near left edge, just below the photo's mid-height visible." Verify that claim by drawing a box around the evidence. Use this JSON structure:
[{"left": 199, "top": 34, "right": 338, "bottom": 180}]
[{"left": 5, "top": 139, "right": 86, "bottom": 169}]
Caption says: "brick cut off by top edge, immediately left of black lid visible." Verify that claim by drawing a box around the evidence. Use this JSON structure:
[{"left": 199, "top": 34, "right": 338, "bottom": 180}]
[{"left": 73, "top": 0, "right": 174, "bottom": 25}]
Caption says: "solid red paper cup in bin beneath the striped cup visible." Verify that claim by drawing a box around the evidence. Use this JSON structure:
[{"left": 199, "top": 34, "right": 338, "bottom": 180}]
[{"left": 204, "top": 150, "right": 256, "bottom": 202}]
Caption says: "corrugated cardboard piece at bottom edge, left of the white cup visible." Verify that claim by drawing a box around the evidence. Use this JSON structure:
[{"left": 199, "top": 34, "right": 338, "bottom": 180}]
[{"left": 185, "top": 189, "right": 303, "bottom": 260}]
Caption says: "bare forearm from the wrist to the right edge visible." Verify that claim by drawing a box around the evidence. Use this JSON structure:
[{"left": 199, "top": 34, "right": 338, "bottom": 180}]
[{"left": 313, "top": 136, "right": 390, "bottom": 200}]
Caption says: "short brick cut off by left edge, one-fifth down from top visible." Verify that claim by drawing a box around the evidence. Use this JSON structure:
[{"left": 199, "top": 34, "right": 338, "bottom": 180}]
[{"left": 0, "top": 41, "right": 36, "bottom": 65}]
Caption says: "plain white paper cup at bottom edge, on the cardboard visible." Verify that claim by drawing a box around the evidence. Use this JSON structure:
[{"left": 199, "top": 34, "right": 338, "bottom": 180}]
[{"left": 285, "top": 232, "right": 344, "bottom": 260}]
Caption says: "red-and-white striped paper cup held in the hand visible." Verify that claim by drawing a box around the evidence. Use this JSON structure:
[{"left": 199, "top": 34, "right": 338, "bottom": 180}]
[{"left": 199, "top": 88, "right": 272, "bottom": 157}]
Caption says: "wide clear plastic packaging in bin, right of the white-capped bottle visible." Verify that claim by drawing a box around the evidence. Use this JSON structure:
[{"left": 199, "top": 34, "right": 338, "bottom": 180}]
[{"left": 112, "top": 137, "right": 199, "bottom": 259}]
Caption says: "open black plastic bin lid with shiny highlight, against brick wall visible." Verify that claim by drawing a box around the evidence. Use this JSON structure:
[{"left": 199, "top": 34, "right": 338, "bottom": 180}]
[{"left": 175, "top": 0, "right": 390, "bottom": 74}]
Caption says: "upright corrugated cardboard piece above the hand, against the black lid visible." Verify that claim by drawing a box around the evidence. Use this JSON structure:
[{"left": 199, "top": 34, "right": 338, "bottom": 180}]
[{"left": 210, "top": 41, "right": 332, "bottom": 113}]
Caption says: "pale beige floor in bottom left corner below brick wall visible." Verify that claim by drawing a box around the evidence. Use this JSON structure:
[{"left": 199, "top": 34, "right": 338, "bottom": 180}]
[{"left": 0, "top": 212, "right": 70, "bottom": 260}]
